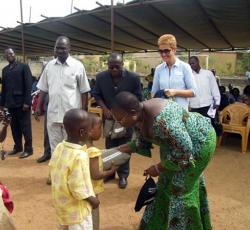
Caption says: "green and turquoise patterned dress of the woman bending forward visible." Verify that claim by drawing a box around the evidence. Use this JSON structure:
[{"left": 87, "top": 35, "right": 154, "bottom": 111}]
[{"left": 130, "top": 101, "right": 216, "bottom": 230}]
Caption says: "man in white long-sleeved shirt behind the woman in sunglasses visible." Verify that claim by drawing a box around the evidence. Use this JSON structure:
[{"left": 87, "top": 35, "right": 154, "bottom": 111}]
[{"left": 189, "top": 56, "right": 221, "bottom": 117}]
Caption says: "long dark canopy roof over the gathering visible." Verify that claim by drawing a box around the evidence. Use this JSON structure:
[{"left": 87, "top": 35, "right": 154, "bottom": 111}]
[{"left": 0, "top": 0, "right": 250, "bottom": 55}]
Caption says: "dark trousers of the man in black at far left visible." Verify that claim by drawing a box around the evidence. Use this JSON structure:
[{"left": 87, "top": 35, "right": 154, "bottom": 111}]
[{"left": 8, "top": 108, "right": 33, "bottom": 153}]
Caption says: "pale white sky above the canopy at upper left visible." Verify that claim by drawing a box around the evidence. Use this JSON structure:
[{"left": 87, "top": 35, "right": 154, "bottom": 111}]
[{"left": 0, "top": 0, "right": 128, "bottom": 27}]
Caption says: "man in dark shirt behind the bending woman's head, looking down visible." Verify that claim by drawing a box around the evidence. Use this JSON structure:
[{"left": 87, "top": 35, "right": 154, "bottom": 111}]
[{"left": 93, "top": 53, "right": 142, "bottom": 188}]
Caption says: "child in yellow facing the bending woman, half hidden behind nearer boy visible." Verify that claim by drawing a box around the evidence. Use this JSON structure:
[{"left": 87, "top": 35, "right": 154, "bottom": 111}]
[{"left": 87, "top": 113, "right": 119, "bottom": 230}]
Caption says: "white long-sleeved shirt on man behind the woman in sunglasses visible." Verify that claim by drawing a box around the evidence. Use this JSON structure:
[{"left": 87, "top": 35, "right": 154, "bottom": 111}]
[{"left": 189, "top": 69, "right": 220, "bottom": 109}]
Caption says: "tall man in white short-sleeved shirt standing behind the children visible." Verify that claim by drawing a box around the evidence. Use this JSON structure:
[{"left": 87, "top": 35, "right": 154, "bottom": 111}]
[{"left": 35, "top": 36, "right": 90, "bottom": 153}]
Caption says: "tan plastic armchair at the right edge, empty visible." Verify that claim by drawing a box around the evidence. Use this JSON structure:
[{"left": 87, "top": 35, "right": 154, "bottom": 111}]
[{"left": 218, "top": 102, "right": 250, "bottom": 153}]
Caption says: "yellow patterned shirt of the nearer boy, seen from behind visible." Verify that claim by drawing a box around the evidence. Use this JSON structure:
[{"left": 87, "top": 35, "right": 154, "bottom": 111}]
[{"left": 49, "top": 141, "right": 95, "bottom": 225}]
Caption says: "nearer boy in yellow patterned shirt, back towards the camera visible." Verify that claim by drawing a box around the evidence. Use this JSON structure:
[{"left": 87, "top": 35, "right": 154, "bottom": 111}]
[{"left": 49, "top": 109, "right": 99, "bottom": 230}]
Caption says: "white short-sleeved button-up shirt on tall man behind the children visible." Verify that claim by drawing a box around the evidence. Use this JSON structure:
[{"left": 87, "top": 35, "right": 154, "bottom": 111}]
[{"left": 37, "top": 56, "right": 90, "bottom": 123}]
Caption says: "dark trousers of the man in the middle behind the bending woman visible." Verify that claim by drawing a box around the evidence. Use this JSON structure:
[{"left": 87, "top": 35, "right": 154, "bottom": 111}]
[{"left": 105, "top": 136, "right": 131, "bottom": 178}]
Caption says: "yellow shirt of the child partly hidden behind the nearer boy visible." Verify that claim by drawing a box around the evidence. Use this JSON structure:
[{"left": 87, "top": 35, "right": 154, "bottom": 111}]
[{"left": 87, "top": 147, "right": 104, "bottom": 194}]
